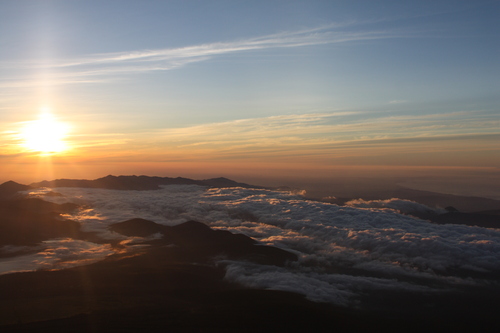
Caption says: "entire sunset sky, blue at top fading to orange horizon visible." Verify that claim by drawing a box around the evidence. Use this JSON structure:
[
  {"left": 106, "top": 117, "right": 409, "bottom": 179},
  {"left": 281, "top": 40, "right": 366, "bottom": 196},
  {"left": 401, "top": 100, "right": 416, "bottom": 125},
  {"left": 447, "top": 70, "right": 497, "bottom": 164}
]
[{"left": 0, "top": 0, "right": 500, "bottom": 192}]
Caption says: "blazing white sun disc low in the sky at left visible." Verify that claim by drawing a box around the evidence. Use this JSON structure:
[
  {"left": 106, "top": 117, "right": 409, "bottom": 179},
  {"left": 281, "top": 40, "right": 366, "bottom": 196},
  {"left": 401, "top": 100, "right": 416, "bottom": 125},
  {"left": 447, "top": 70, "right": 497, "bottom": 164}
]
[{"left": 21, "top": 111, "right": 69, "bottom": 154}]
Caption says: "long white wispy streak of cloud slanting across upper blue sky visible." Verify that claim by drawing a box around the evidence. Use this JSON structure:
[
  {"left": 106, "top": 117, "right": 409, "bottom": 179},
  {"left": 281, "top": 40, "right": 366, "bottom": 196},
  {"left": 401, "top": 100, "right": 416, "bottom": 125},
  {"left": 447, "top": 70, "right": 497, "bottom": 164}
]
[{"left": 0, "top": 23, "right": 409, "bottom": 88}]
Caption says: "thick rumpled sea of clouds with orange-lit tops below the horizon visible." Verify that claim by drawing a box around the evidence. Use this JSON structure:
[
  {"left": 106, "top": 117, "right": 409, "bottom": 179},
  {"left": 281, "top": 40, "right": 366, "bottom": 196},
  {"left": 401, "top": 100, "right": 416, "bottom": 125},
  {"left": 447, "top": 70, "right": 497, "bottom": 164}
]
[{"left": 0, "top": 185, "right": 500, "bottom": 305}]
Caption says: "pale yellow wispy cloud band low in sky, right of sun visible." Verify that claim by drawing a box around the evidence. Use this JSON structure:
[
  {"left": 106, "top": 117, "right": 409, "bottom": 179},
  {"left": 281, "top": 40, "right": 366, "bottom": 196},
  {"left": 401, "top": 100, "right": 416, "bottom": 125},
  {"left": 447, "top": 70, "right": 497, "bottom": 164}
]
[{"left": 159, "top": 111, "right": 500, "bottom": 144}]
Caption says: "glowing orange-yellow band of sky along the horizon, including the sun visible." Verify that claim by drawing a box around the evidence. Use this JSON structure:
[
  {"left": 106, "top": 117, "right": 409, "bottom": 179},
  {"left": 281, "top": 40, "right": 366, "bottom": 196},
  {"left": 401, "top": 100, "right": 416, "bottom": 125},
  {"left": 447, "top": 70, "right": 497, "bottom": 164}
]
[{"left": 1, "top": 107, "right": 500, "bottom": 197}]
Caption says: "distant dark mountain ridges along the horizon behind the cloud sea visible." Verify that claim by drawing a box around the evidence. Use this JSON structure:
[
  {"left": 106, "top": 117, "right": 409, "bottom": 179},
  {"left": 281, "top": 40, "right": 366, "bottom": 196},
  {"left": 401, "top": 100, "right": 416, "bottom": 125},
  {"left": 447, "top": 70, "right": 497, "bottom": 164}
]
[{"left": 0, "top": 175, "right": 500, "bottom": 228}]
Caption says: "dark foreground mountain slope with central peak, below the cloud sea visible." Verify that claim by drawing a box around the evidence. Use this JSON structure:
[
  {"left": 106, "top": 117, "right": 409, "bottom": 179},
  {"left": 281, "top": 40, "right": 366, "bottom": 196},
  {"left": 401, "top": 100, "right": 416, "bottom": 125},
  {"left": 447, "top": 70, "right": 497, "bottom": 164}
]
[{"left": 0, "top": 219, "right": 499, "bottom": 332}]
